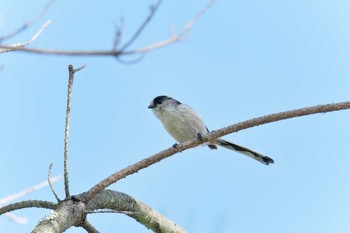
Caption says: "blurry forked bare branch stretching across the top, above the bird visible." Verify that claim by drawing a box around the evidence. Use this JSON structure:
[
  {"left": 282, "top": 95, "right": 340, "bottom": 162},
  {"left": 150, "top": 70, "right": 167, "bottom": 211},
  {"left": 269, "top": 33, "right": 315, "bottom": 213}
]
[{"left": 8, "top": 0, "right": 215, "bottom": 57}]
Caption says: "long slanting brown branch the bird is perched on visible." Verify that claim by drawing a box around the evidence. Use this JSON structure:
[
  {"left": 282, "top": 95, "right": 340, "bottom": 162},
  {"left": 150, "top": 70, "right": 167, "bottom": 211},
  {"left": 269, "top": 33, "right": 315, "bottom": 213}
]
[{"left": 83, "top": 102, "right": 350, "bottom": 202}]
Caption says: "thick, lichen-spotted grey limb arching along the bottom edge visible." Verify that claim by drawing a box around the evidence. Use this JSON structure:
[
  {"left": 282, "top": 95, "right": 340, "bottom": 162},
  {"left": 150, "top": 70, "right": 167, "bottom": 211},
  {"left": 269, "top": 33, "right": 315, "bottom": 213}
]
[{"left": 32, "top": 190, "right": 186, "bottom": 233}]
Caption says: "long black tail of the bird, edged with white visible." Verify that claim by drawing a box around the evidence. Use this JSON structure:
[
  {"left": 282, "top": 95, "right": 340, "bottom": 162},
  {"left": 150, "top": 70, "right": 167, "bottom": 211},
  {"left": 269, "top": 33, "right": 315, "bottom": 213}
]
[{"left": 216, "top": 139, "right": 274, "bottom": 165}]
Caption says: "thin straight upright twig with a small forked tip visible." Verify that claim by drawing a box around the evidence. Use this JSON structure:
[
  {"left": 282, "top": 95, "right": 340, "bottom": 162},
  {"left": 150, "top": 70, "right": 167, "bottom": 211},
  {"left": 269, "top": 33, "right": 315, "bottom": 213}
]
[{"left": 64, "top": 65, "right": 85, "bottom": 199}]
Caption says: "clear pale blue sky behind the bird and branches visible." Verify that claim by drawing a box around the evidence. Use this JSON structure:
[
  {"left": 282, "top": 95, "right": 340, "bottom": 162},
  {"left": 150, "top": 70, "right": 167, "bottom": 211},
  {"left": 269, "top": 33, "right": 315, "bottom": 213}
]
[{"left": 0, "top": 0, "right": 350, "bottom": 233}]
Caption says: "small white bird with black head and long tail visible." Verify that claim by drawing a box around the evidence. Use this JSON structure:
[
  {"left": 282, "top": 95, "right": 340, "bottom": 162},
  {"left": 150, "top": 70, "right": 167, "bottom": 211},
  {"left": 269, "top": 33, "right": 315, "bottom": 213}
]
[{"left": 148, "top": 95, "right": 274, "bottom": 165}]
